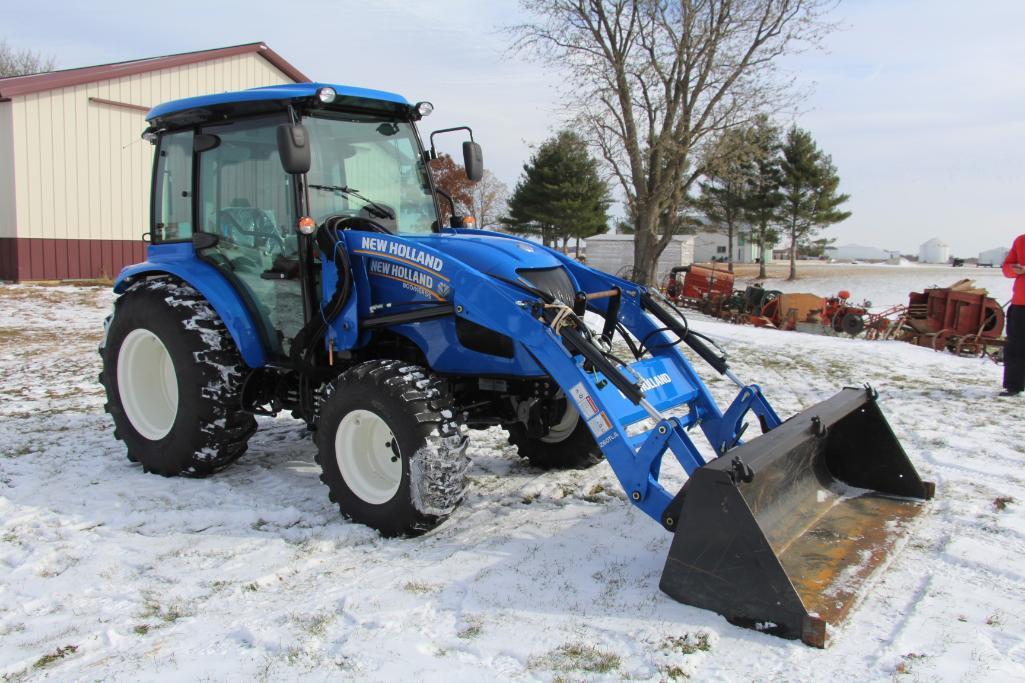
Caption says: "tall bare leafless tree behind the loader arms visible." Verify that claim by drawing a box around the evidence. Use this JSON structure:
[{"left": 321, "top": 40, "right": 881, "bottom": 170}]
[{"left": 511, "top": 0, "right": 834, "bottom": 283}]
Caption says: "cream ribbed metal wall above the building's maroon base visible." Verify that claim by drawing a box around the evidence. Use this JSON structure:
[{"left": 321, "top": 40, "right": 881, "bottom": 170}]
[{"left": 9, "top": 53, "right": 292, "bottom": 240}]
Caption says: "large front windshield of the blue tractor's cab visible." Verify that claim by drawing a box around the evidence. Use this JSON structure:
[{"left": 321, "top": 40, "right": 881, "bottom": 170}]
[{"left": 303, "top": 111, "right": 438, "bottom": 234}]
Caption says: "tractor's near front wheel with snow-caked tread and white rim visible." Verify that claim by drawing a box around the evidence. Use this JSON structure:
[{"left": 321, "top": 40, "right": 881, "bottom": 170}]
[{"left": 315, "top": 360, "right": 469, "bottom": 536}]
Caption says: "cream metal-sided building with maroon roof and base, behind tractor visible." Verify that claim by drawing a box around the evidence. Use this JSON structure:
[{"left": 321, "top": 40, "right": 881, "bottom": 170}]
[{"left": 0, "top": 43, "right": 310, "bottom": 281}]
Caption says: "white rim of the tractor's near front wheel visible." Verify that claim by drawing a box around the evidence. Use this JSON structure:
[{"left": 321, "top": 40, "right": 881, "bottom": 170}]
[{"left": 334, "top": 410, "right": 402, "bottom": 506}]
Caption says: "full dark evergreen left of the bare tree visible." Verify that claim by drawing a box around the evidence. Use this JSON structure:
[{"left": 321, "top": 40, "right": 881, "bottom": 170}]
[{"left": 501, "top": 130, "right": 612, "bottom": 252}]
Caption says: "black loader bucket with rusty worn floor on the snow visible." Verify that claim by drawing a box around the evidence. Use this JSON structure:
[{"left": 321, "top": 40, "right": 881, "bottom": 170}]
[{"left": 660, "top": 389, "right": 934, "bottom": 647}]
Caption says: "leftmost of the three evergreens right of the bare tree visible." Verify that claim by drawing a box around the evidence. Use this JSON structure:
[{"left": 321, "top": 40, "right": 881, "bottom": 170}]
[{"left": 697, "top": 128, "right": 753, "bottom": 273}]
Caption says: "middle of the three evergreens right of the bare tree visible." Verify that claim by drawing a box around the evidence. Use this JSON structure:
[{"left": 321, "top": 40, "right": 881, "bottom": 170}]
[{"left": 744, "top": 116, "right": 783, "bottom": 278}]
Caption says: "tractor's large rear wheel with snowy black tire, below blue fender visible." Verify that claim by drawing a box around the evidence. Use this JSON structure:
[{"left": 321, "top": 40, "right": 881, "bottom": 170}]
[{"left": 99, "top": 279, "right": 256, "bottom": 477}]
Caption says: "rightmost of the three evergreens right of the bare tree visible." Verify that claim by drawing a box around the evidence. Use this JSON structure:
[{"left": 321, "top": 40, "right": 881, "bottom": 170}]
[{"left": 780, "top": 126, "right": 851, "bottom": 280}]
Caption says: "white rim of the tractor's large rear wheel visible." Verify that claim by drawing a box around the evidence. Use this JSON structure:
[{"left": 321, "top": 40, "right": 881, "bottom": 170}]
[{"left": 118, "top": 327, "right": 178, "bottom": 441}]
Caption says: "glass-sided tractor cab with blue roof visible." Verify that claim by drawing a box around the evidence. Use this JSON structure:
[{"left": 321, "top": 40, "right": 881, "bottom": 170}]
[{"left": 145, "top": 83, "right": 481, "bottom": 358}]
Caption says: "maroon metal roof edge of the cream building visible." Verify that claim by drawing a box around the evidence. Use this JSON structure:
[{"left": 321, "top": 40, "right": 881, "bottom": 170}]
[{"left": 0, "top": 43, "right": 310, "bottom": 99}]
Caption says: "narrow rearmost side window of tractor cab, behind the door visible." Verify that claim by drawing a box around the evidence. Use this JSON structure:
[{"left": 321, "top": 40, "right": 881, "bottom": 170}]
[{"left": 150, "top": 130, "right": 193, "bottom": 243}]
